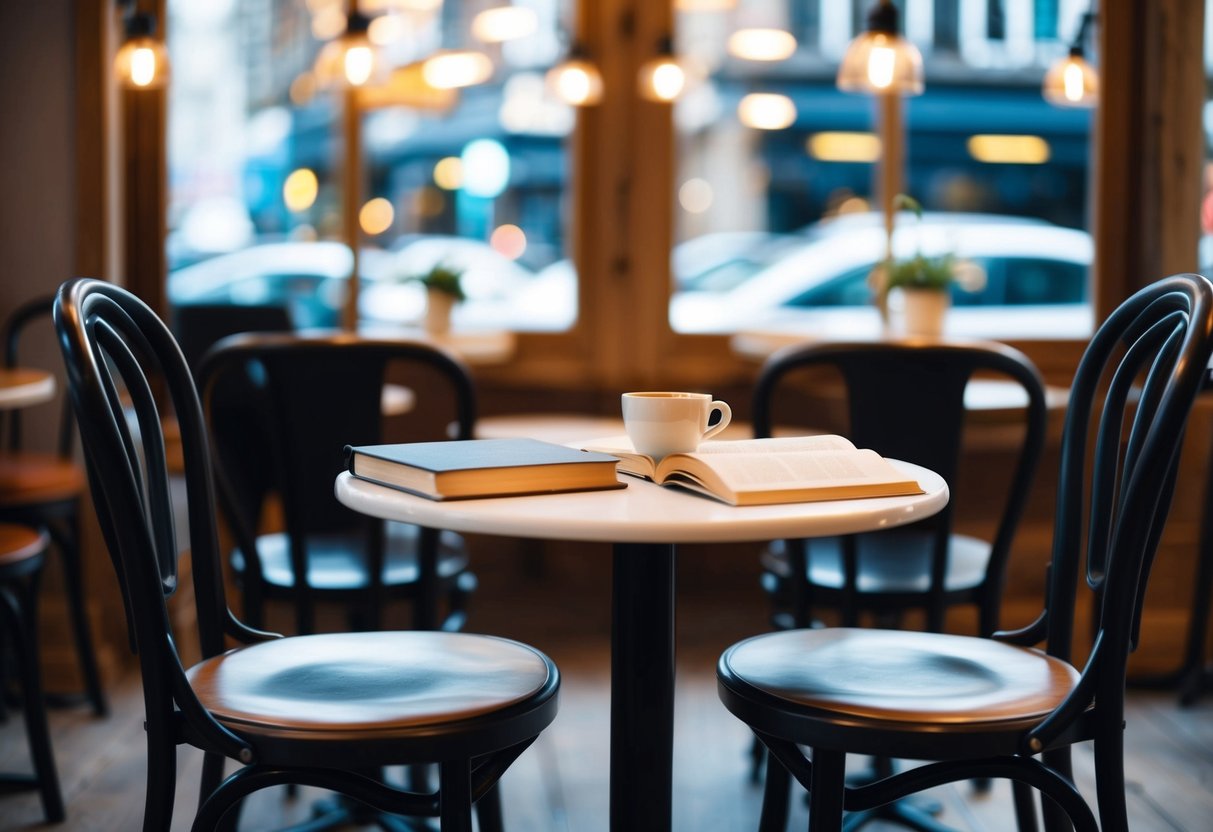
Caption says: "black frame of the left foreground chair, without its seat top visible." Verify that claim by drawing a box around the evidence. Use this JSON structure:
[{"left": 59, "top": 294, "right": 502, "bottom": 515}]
[{"left": 55, "top": 279, "right": 559, "bottom": 832}]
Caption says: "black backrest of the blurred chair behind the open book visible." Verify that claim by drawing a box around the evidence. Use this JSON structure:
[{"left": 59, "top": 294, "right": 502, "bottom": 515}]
[{"left": 752, "top": 341, "right": 1047, "bottom": 606}]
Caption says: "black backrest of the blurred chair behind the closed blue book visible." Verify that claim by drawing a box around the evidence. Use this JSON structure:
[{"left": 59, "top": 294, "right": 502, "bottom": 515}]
[{"left": 198, "top": 335, "right": 475, "bottom": 538}]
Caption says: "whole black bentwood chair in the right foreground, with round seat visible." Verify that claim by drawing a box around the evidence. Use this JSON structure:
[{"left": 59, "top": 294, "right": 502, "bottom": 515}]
[{"left": 717, "top": 274, "right": 1213, "bottom": 832}]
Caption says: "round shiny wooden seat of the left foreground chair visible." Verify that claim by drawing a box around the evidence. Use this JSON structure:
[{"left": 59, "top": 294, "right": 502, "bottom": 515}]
[{"left": 187, "top": 632, "right": 556, "bottom": 762}]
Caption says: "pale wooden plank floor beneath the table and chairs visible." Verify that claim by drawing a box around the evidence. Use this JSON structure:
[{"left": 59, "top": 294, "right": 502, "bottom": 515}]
[{"left": 0, "top": 562, "right": 1213, "bottom": 832}]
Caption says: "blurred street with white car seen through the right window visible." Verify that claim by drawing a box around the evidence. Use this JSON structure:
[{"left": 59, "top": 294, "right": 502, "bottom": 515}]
[{"left": 670, "top": 0, "right": 1101, "bottom": 338}]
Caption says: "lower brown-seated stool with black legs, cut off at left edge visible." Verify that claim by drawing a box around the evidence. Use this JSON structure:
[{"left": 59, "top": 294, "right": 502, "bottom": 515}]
[{"left": 0, "top": 523, "right": 64, "bottom": 824}]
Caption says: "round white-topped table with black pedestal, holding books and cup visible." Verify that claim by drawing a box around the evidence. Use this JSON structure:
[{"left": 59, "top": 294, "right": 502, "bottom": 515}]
[{"left": 335, "top": 461, "right": 949, "bottom": 832}]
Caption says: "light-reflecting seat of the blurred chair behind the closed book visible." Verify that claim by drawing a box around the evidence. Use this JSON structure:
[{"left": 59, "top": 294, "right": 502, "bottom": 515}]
[{"left": 232, "top": 523, "right": 468, "bottom": 592}]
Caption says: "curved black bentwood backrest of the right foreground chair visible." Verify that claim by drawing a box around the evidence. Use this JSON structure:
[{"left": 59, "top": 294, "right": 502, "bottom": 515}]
[{"left": 1002, "top": 274, "right": 1213, "bottom": 752}]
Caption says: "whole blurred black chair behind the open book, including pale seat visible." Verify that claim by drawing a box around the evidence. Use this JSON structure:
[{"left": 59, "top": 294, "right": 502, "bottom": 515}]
[{"left": 753, "top": 342, "right": 1046, "bottom": 636}]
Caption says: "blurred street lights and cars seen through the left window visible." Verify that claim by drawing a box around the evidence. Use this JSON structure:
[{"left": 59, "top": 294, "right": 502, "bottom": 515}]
[{"left": 167, "top": 0, "right": 576, "bottom": 339}]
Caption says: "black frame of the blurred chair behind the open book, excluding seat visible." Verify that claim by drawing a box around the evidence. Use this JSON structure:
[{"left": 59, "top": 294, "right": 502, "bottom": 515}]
[{"left": 752, "top": 342, "right": 1047, "bottom": 636}]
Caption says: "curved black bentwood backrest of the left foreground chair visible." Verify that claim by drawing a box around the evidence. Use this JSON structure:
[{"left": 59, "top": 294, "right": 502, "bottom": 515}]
[{"left": 55, "top": 279, "right": 260, "bottom": 759}]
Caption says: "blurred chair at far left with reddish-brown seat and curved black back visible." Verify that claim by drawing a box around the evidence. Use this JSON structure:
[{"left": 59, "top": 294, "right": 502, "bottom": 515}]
[{"left": 0, "top": 297, "right": 109, "bottom": 716}]
